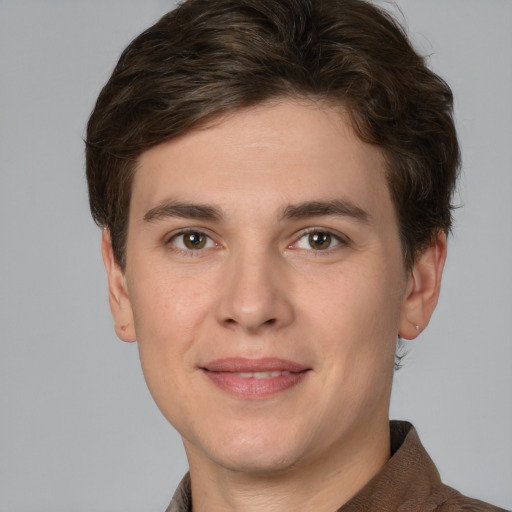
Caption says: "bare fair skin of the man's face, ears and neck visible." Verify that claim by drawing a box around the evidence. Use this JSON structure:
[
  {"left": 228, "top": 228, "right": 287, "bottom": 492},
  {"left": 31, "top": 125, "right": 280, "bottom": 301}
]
[{"left": 103, "top": 99, "right": 446, "bottom": 512}]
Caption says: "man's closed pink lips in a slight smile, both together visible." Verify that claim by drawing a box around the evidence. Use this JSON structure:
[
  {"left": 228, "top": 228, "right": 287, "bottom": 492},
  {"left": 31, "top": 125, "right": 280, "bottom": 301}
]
[{"left": 200, "top": 357, "right": 311, "bottom": 400}]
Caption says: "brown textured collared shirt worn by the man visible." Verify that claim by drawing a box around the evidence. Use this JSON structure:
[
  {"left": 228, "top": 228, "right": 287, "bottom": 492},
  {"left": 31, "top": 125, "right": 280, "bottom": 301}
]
[{"left": 166, "top": 421, "right": 506, "bottom": 512}]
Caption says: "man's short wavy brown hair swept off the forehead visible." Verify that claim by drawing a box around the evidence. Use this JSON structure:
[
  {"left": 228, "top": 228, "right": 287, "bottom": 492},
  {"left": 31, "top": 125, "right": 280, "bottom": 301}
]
[{"left": 86, "top": 0, "right": 460, "bottom": 268}]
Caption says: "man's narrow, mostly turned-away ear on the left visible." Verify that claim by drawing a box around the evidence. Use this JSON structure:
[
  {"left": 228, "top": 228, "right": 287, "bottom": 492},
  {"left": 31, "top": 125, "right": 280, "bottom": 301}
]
[{"left": 101, "top": 228, "right": 136, "bottom": 342}]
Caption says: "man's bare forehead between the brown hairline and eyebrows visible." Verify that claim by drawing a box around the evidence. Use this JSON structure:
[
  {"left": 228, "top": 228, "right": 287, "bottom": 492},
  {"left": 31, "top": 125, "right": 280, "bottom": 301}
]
[{"left": 131, "top": 100, "right": 391, "bottom": 218}]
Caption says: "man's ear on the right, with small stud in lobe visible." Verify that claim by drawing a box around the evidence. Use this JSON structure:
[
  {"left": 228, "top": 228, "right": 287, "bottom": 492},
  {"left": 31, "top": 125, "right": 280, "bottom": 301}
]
[{"left": 398, "top": 231, "right": 446, "bottom": 340}]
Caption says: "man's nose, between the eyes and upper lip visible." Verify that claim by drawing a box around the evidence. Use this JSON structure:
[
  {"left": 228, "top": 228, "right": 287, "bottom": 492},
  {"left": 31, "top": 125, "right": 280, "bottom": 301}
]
[{"left": 217, "top": 247, "right": 294, "bottom": 334}]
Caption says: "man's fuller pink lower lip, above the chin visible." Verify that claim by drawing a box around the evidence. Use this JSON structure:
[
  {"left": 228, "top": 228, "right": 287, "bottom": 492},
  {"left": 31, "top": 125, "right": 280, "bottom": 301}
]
[{"left": 203, "top": 370, "right": 309, "bottom": 399}]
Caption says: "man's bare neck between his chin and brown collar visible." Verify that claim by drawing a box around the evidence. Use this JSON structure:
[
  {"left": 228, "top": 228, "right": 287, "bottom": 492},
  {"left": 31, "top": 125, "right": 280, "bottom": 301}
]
[{"left": 185, "top": 418, "right": 390, "bottom": 512}]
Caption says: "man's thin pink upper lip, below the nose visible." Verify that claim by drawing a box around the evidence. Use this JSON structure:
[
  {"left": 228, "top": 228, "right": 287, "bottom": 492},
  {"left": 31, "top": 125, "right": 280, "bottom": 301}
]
[{"left": 201, "top": 357, "right": 310, "bottom": 373}]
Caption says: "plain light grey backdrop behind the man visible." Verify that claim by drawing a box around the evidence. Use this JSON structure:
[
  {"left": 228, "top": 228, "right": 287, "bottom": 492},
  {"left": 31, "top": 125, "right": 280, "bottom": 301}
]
[{"left": 0, "top": 0, "right": 512, "bottom": 512}]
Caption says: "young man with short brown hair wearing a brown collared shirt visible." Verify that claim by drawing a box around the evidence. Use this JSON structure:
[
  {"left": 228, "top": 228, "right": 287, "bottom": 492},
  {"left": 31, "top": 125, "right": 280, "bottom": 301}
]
[{"left": 87, "top": 0, "right": 506, "bottom": 512}]
